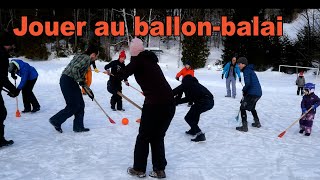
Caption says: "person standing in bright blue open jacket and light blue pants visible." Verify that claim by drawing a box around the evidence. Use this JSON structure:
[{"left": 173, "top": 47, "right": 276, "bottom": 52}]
[{"left": 221, "top": 57, "right": 241, "bottom": 98}]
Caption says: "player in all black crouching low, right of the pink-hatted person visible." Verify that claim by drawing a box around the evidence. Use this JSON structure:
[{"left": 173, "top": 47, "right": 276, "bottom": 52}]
[{"left": 173, "top": 75, "right": 214, "bottom": 142}]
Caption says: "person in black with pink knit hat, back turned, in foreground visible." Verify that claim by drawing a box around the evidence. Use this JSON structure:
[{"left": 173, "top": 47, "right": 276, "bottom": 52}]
[{"left": 120, "top": 38, "right": 176, "bottom": 178}]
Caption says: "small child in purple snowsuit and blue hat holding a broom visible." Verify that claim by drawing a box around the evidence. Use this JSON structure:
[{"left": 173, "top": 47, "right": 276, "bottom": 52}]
[{"left": 299, "top": 83, "right": 320, "bottom": 136}]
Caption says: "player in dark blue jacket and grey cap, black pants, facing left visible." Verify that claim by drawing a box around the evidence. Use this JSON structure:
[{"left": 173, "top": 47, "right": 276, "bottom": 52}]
[{"left": 236, "top": 57, "right": 262, "bottom": 132}]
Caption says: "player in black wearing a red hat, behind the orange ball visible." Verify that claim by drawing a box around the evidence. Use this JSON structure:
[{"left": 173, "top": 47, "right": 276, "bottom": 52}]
[{"left": 104, "top": 51, "right": 130, "bottom": 111}]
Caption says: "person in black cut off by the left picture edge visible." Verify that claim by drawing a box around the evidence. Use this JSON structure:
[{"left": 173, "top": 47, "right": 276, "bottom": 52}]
[{"left": 0, "top": 31, "right": 20, "bottom": 147}]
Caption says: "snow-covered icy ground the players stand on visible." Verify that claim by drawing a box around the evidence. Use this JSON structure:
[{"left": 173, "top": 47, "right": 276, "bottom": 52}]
[{"left": 0, "top": 48, "right": 320, "bottom": 180}]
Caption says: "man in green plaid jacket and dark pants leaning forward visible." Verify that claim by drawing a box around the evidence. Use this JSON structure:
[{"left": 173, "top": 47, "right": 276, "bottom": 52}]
[{"left": 49, "top": 45, "right": 99, "bottom": 133}]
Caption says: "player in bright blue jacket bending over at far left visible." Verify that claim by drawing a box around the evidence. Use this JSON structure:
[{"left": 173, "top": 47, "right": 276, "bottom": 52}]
[{"left": 8, "top": 59, "right": 40, "bottom": 113}]
